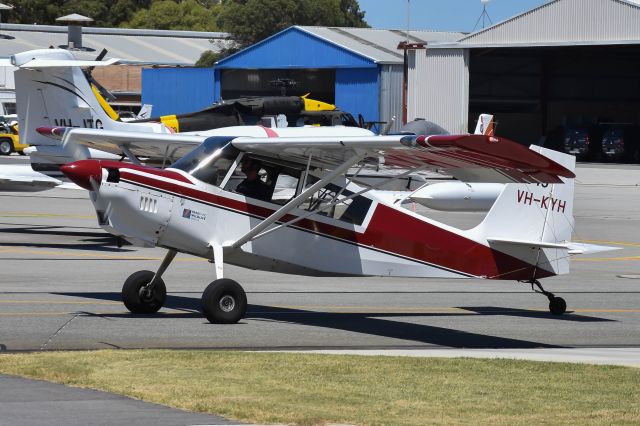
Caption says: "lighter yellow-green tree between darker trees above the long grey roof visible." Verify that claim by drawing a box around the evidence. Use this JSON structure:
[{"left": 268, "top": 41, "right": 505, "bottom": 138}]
[{"left": 120, "top": 0, "right": 220, "bottom": 31}]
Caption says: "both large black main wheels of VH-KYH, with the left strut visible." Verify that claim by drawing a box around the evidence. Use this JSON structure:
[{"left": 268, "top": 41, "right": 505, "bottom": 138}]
[{"left": 122, "top": 250, "right": 247, "bottom": 324}]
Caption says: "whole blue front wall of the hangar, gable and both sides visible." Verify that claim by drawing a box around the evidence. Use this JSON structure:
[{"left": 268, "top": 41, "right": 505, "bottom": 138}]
[{"left": 142, "top": 27, "right": 380, "bottom": 121}]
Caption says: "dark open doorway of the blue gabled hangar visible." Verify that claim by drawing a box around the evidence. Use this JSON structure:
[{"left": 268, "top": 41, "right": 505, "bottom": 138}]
[{"left": 220, "top": 69, "right": 336, "bottom": 104}]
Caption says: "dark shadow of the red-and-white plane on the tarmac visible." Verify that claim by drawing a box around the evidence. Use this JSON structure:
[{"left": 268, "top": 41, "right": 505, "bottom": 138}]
[{"left": 55, "top": 293, "right": 611, "bottom": 349}]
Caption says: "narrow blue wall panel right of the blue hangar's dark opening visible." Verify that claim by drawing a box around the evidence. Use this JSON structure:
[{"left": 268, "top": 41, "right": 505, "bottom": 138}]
[{"left": 336, "top": 67, "right": 380, "bottom": 121}]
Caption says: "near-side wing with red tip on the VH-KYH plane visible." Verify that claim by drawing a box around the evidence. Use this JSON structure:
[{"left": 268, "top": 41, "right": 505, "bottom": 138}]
[{"left": 232, "top": 135, "right": 575, "bottom": 183}]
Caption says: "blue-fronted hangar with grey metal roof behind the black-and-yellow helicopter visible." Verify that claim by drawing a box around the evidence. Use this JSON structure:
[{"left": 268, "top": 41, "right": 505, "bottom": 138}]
[{"left": 142, "top": 26, "right": 463, "bottom": 130}]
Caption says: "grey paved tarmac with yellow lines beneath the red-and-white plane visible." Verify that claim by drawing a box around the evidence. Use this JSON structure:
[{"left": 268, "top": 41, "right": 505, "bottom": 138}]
[{"left": 0, "top": 157, "right": 640, "bottom": 425}]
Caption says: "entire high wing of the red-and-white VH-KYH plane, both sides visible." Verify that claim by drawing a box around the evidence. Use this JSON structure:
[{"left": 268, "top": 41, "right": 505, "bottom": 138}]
[{"left": 64, "top": 129, "right": 575, "bottom": 183}]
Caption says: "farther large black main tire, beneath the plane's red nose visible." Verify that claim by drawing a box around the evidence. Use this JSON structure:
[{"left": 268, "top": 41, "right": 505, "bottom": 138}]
[{"left": 122, "top": 271, "right": 167, "bottom": 314}]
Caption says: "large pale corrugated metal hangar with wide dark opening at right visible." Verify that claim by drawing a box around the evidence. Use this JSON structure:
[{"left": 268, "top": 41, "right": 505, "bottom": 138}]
[{"left": 408, "top": 0, "right": 640, "bottom": 161}]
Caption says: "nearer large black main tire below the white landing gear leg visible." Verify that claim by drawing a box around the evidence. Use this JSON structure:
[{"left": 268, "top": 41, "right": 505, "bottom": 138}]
[{"left": 202, "top": 278, "right": 247, "bottom": 324}]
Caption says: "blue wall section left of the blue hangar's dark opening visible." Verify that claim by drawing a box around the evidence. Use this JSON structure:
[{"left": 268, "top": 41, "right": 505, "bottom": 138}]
[{"left": 142, "top": 68, "right": 219, "bottom": 117}]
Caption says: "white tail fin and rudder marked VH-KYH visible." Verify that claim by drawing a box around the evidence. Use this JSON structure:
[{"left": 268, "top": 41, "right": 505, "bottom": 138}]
[{"left": 470, "top": 146, "right": 575, "bottom": 279}]
